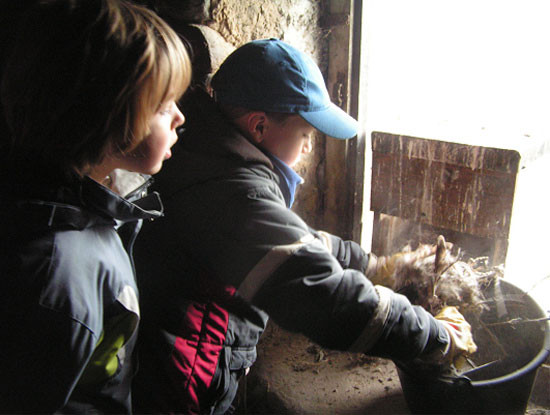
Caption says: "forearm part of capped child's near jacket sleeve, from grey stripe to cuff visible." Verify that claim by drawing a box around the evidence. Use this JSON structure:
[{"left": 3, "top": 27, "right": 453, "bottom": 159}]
[{"left": 240, "top": 234, "right": 448, "bottom": 361}]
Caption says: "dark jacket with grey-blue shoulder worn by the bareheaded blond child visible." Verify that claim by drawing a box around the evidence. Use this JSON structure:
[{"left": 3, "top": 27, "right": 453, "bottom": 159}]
[{"left": 0, "top": 172, "right": 161, "bottom": 413}]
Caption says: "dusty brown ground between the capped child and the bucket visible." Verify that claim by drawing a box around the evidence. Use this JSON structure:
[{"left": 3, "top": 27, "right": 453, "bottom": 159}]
[{"left": 237, "top": 325, "right": 550, "bottom": 415}]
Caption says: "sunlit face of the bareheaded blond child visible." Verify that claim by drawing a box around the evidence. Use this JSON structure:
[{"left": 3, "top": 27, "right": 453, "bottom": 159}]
[{"left": 119, "top": 100, "right": 185, "bottom": 174}]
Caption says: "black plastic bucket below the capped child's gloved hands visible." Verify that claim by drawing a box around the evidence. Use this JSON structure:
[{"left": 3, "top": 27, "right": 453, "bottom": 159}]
[{"left": 396, "top": 280, "right": 550, "bottom": 414}]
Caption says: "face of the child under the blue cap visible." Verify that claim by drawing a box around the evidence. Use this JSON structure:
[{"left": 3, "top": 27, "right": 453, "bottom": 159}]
[{"left": 261, "top": 115, "right": 315, "bottom": 167}]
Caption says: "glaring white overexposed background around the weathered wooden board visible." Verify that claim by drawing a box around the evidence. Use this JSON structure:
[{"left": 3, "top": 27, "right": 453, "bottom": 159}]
[{"left": 360, "top": 0, "right": 550, "bottom": 309}]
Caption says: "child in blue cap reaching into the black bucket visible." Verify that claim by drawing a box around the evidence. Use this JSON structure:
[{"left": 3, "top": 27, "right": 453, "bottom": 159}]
[{"left": 134, "top": 39, "right": 471, "bottom": 414}]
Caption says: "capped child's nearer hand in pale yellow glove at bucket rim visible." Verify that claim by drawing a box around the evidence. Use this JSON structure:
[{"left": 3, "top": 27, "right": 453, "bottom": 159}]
[{"left": 435, "top": 306, "right": 477, "bottom": 369}]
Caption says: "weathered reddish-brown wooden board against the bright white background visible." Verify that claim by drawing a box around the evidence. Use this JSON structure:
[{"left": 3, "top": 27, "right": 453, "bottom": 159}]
[{"left": 371, "top": 132, "right": 520, "bottom": 238}]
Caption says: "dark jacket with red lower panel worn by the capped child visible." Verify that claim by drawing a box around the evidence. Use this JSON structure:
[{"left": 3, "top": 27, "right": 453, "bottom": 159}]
[{"left": 136, "top": 89, "right": 448, "bottom": 413}]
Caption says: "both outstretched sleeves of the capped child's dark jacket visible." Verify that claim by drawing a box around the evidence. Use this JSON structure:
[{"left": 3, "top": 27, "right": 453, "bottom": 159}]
[{"left": 180, "top": 180, "right": 448, "bottom": 360}]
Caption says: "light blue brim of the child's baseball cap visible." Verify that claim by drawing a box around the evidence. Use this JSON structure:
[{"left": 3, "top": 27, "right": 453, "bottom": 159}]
[{"left": 298, "top": 103, "right": 359, "bottom": 140}]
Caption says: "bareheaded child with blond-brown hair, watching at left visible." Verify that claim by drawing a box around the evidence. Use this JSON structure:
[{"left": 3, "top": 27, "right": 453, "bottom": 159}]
[{"left": 0, "top": 0, "right": 191, "bottom": 414}]
